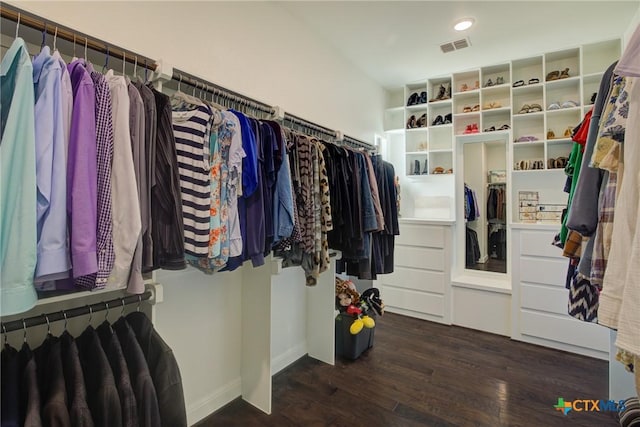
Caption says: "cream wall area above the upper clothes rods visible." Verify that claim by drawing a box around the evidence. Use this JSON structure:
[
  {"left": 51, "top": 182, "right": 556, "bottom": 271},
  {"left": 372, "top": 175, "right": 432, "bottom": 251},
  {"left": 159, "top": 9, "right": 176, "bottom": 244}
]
[{"left": 7, "top": 1, "right": 384, "bottom": 142}]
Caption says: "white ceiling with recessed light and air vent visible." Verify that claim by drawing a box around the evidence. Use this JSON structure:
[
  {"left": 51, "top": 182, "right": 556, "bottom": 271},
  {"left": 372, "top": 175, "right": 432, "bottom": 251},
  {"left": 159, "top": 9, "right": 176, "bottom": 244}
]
[{"left": 279, "top": 0, "right": 640, "bottom": 88}]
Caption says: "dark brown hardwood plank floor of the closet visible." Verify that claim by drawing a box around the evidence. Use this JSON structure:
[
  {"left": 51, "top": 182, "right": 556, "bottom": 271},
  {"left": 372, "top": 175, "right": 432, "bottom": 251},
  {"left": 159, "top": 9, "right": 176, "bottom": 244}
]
[{"left": 198, "top": 313, "right": 619, "bottom": 427}]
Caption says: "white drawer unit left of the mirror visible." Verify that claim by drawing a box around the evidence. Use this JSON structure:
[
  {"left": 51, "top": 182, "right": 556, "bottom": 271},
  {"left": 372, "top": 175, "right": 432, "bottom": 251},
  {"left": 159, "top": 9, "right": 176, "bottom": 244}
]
[{"left": 379, "top": 219, "right": 453, "bottom": 324}]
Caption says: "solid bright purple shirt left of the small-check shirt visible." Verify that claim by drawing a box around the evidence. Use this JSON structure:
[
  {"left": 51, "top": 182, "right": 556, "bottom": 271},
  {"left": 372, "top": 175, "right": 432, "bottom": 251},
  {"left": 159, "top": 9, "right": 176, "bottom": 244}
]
[{"left": 67, "top": 60, "right": 98, "bottom": 277}]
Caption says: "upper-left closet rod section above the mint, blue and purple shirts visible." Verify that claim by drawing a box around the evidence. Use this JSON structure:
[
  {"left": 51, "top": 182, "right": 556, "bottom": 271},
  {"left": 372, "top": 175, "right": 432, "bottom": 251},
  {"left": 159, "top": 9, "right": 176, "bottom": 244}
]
[{"left": 0, "top": 3, "right": 156, "bottom": 71}]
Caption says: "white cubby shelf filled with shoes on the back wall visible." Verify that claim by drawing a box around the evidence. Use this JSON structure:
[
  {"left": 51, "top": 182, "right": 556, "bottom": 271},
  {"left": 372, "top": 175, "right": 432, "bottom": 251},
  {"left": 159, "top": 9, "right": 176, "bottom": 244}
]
[{"left": 385, "top": 39, "right": 622, "bottom": 177}]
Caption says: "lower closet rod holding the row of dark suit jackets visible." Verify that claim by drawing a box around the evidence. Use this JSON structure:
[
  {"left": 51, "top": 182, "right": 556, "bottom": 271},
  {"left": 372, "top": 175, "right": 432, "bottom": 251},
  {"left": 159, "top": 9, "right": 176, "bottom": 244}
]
[{"left": 0, "top": 291, "right": 153, "bottom": 333}]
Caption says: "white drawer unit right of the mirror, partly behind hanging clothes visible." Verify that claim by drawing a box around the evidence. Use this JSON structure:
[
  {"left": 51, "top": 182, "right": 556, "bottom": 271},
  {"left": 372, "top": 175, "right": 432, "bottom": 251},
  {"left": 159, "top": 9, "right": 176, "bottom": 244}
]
[{"left": 511, "top": 225, "right": 609, "bottom": 359}]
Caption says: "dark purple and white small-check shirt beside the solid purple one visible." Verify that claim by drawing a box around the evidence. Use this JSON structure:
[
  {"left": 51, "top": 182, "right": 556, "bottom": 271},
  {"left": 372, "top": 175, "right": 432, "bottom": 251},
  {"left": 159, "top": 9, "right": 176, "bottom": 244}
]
[{"left": 76, "top": 70, "right": 116, "bottom": 289}]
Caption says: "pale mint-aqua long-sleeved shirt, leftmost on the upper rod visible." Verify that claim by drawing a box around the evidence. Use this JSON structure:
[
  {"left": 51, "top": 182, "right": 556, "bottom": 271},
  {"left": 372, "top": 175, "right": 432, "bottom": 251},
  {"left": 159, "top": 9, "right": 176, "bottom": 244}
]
[{"left": 0, "top": 38, "right": 37, "bottom": 316}]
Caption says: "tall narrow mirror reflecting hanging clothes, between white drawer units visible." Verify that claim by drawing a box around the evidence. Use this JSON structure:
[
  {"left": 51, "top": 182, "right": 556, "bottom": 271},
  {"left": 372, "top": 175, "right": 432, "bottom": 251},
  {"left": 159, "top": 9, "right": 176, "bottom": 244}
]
[{"left": 461, "top": 139, "right": 508, "bottom": 273}]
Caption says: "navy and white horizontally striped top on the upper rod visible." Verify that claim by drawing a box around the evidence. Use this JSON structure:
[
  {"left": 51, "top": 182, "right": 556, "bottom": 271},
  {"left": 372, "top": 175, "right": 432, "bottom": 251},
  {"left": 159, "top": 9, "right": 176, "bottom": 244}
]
[{"left": 172, "top": 105, "right": 212, "bottom": 257}]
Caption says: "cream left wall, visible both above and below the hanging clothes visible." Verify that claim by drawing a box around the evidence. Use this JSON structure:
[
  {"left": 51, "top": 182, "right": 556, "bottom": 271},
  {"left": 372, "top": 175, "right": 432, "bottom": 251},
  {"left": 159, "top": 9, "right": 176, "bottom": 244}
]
[{"left": 7, "top": 1, "right": 384, "bottom": 423}]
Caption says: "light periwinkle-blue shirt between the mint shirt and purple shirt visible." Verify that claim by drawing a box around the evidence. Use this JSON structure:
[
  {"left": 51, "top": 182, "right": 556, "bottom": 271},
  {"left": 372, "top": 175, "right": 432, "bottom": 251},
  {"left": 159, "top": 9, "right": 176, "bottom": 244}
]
[{"left": 33, "top": 46, "right": 71, "bottom": 280}]
